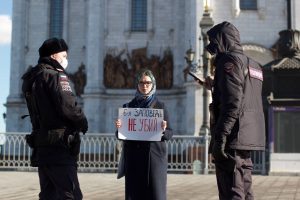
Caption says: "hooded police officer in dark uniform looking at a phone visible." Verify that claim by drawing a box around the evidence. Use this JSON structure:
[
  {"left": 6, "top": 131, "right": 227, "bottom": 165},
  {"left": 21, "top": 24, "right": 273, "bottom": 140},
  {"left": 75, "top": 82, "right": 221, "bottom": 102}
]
[{"left": 206, "top": 21, "right": 265, "bottom": 200}]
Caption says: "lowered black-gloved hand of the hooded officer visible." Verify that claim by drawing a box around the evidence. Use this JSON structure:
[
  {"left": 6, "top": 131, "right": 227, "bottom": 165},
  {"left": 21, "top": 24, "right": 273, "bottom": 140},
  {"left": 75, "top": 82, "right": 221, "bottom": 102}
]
[{"left": 212, "top": 134, "right": 228, "bottom": 161}]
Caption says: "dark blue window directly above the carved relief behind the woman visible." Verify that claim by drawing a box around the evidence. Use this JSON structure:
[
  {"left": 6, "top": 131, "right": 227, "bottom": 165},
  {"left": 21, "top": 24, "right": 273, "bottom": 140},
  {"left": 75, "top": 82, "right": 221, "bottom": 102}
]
[{"left": 131, "top": 0, "right": 147, "bottom": 32}]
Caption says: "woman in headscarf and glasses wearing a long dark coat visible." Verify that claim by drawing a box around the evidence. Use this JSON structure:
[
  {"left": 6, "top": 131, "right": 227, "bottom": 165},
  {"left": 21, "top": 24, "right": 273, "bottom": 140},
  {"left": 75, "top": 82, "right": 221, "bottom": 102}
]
[{"left": 115, "top": 70, "right": 173, "bottom": 200}]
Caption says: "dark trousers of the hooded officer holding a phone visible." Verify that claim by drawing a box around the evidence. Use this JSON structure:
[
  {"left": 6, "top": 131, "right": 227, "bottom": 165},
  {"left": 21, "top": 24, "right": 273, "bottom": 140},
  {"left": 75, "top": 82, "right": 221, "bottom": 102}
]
[{"left": 215, "top": 150, "right": 254, "bottom": 200}]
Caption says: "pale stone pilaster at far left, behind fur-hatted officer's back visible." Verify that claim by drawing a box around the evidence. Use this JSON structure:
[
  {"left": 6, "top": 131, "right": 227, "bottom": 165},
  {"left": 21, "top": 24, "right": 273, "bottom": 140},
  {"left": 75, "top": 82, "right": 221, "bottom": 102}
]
[{"left": 5, "top": 1, "right": 30, "bottom": 132}]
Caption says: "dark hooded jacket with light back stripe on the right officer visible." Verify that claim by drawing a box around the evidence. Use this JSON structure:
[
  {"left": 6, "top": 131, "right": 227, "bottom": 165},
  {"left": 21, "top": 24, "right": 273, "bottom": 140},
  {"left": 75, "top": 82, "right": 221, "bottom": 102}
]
[{"left": 208, "top": 23, "right": 265, "bottom": 150}]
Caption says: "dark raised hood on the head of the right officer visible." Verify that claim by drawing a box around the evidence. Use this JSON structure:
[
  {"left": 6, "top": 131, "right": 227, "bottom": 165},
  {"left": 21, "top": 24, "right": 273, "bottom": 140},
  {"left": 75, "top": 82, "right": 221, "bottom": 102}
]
[{"left": 206, "top": 21, "right": 243, "bottom": 55}]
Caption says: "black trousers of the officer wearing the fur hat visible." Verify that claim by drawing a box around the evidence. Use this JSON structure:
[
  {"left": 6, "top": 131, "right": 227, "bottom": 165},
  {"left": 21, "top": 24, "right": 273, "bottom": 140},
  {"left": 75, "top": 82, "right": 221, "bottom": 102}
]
[{"left": 38, "top": 165, "right": 82, "bottom": 200}]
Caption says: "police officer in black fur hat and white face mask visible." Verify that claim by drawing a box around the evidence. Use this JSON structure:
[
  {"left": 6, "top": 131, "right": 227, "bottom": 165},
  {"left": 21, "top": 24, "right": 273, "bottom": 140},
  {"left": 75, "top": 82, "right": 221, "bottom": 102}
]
[{"left": 22, "top": 38, "right": 88, "bottom": 200}]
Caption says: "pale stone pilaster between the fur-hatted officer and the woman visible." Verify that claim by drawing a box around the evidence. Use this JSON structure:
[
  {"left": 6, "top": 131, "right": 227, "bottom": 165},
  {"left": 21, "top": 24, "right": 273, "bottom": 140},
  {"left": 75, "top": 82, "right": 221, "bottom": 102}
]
[{"left": 83, "top": 0, "right": 105, "bottom": 132}]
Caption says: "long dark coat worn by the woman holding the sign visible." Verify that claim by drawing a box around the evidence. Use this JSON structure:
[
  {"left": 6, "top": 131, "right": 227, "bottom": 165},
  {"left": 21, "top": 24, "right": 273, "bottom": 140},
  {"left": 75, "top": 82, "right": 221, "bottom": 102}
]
[{"left": 117, "top": 97, "right": 173, "bottom": 200}]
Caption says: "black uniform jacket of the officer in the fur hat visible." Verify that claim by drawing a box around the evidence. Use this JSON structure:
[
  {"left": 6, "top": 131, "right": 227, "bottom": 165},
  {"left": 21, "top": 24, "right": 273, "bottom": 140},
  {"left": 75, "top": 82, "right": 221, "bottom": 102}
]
[{"left": 22, "top": 57, "right": 88, "bottom": 166}]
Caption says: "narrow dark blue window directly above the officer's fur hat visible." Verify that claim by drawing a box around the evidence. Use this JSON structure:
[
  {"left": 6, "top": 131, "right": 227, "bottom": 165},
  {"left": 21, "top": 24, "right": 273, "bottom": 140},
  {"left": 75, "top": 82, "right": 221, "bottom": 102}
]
[{"left": 49, "top": 0, "right": 64, "bottom": 38}]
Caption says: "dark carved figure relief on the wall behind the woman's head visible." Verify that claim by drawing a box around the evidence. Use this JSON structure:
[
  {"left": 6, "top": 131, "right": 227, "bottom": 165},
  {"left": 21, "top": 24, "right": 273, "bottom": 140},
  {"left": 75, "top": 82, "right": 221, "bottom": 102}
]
[{"left": 104, "top": 47, "right": 173, "bottom": 89}]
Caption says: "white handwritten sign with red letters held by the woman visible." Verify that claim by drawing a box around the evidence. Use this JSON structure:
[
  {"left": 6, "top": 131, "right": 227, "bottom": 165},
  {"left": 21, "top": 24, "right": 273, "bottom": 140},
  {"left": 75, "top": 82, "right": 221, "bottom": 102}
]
[{"left": 118, "top": 108, "right": 164, "bottom": 141}]
